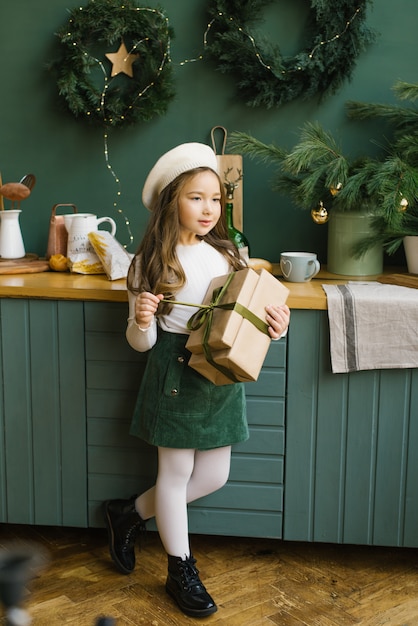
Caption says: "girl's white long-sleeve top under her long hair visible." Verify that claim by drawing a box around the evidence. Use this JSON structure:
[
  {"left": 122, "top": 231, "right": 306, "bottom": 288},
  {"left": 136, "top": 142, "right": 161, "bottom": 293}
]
[{"left": 126, "top": 241, "right": 231, "bottom": 352}]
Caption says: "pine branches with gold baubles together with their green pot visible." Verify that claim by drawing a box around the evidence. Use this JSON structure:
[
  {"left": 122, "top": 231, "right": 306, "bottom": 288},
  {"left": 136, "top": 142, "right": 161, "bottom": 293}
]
[{"left": 231, "top": 83, "right": 418, "bottom": 276}]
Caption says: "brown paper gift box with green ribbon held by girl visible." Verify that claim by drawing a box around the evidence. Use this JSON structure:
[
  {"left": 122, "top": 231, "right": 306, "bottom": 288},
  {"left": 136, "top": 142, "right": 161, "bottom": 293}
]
[{"left": 186, "top": 268, "right": 289, "bottom": 385}]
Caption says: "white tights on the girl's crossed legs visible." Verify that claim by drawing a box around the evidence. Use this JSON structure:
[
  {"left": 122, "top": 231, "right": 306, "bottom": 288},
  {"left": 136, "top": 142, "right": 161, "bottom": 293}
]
[{"left": 135, "top": 446, "right": 231, "bottom": 558}]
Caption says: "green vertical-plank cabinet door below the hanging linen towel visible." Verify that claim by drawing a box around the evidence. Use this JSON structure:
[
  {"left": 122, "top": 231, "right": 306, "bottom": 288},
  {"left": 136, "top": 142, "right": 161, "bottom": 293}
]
[{"left": 284, "top": 311, "right": 418, "bottom": 547}]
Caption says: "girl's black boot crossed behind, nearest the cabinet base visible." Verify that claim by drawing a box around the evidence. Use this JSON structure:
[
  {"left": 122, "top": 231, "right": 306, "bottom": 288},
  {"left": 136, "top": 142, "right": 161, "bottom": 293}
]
[{"left": 103, "top": 496, "right": 145, "bottom": 574}]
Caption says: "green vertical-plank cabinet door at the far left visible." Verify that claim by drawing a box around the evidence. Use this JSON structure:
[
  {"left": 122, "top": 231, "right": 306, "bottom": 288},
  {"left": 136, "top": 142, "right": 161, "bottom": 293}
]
[{"left": 0, "top": 299, "right": 87, "bottom": 526}]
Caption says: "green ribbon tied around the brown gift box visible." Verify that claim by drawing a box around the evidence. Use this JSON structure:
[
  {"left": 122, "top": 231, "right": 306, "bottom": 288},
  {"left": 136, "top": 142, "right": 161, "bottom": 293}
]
[{"left": 162, "top": 272, "right": 269, "bottom": 383}]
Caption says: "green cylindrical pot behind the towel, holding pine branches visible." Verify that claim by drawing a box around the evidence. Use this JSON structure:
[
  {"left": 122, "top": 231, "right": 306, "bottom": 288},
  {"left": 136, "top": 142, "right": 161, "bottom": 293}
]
[{"left": 327, "top": 211, "right": 383, "bottom": 276}]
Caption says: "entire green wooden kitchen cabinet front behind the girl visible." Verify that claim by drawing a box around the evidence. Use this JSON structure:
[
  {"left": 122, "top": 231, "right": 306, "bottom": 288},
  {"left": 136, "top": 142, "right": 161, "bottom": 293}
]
[{"left": 0, "top": 298, "right": 418, "bottom": 547}]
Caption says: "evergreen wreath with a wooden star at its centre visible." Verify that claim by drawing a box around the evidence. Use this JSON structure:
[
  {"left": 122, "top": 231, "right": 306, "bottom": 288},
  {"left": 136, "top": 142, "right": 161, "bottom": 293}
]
[{"left": 51, "top": 0, "right": 174, "bottom": 126}]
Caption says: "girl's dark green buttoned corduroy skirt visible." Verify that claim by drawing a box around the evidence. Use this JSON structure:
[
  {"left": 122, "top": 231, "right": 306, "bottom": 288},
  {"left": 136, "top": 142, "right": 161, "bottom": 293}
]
[{"left": 130, "top": 330, "right": 248, "bottom": 450}]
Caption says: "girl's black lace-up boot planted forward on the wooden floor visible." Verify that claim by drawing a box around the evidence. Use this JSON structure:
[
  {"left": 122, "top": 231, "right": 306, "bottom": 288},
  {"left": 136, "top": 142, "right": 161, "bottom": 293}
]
[{"left": 165, "top": 555, "right": 218, "bottom": 617}]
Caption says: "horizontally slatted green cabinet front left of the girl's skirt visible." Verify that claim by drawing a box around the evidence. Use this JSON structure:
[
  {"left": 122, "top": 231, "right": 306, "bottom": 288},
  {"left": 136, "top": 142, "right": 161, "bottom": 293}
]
[{"left": 85, "top": 302, "right": 151, "bottom": 527}]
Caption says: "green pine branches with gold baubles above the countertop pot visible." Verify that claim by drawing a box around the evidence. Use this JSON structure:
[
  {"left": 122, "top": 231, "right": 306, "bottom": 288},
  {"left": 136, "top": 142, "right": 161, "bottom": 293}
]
[{"left": 232, "top": 83, "right": 418, "bottom": 251}]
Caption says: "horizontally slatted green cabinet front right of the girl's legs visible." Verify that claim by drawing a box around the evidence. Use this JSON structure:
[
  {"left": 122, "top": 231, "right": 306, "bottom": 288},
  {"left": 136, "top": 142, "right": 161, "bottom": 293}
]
[{"left": 189, "top": 339, "right": 286, "bottom": 538}]
